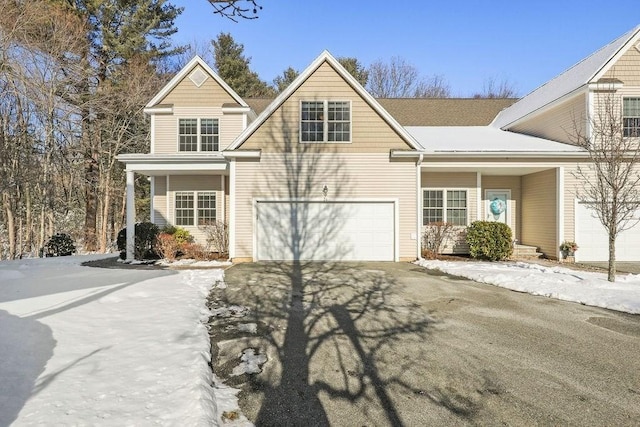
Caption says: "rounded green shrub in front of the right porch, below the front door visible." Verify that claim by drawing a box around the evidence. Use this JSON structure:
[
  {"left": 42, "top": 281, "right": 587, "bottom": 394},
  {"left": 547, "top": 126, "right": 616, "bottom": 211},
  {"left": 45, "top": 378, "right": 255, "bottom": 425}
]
[{"left": 467, "top": 221, "right": 513, "bottom": 261}]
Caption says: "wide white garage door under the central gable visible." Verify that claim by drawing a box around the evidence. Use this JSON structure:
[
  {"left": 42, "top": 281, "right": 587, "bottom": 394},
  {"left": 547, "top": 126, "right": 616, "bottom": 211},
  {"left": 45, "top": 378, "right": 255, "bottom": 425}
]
[{"left": 256, "top": 201, "right": 395, "bottom": 261}]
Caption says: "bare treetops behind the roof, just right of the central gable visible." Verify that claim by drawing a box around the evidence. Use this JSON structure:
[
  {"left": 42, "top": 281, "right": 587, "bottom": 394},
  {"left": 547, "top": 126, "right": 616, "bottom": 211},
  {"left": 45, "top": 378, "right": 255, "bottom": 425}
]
[{"left": 367, "top": 56, "right": 450, "bottom": 98}]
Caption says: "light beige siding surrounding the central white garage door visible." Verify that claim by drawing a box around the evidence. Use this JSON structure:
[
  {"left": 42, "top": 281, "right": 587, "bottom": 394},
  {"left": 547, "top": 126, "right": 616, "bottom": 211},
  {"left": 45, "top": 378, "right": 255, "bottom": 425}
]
[{"left": 235, "top": 152, "right": 417, "bottom": 259}]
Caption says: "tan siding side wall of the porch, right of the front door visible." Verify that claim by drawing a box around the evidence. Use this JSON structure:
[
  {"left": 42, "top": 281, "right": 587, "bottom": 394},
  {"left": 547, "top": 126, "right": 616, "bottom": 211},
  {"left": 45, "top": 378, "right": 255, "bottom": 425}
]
[{"left": 520, "top": 169, "right": 560, "bottom": 258}]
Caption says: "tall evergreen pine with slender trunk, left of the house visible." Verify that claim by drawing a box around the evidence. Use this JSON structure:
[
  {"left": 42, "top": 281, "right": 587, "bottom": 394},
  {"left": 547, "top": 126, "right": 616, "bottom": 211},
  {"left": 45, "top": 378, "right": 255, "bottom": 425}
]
[{"left": 53, "top": 0, "right": 182, "bottom": 251}]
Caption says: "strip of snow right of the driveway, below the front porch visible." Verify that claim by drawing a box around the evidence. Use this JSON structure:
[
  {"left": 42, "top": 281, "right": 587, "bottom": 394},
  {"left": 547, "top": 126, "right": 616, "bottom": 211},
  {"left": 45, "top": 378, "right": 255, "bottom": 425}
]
[{"left": 417, "top": 260, "right": 640, "bottom": 314}]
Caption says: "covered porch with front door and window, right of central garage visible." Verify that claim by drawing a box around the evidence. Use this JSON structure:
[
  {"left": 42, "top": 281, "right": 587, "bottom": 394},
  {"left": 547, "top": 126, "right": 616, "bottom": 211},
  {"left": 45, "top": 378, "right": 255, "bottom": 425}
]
[{"left": 420, "top": 160, "right": 564, "bottom": 258}]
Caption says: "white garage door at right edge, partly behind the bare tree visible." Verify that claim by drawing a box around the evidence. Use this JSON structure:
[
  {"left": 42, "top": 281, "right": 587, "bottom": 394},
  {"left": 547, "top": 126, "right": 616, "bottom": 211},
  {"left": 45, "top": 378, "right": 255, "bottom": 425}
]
[{"left": 576, "top": 203, "right": 640, "bottom": 261}]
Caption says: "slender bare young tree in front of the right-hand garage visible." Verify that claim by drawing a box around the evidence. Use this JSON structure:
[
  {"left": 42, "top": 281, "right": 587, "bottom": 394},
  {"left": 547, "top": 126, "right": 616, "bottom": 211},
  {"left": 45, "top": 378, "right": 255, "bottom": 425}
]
[{"left": 571, "top": 93, "right": 640, "bottom": 282}]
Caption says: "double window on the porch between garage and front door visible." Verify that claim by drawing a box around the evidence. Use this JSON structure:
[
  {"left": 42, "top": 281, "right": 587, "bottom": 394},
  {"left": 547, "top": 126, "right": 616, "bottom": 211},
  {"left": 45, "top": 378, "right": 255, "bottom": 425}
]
[{"left": 422, "top": 189, "right": 467, "bottom": 225}]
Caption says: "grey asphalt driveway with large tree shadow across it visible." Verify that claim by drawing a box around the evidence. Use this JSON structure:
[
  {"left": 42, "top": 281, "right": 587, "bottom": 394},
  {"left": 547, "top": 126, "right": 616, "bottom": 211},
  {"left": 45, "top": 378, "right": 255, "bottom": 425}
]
[{"left": 212, "top": 263, "right": 640, "bottom": 426}]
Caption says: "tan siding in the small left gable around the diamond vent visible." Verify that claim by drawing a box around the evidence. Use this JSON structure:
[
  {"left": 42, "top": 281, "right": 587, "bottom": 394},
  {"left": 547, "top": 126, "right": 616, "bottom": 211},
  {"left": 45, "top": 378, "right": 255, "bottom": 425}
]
[{"left": 158, "top": 64, "right": 236, "bottom": 107}]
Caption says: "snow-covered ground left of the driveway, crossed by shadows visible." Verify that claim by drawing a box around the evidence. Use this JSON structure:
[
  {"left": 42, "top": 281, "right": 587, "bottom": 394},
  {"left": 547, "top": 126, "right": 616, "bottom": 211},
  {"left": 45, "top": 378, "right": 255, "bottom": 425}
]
[{"left": 0, "top": 255, "right": 229, "bottom": 426}]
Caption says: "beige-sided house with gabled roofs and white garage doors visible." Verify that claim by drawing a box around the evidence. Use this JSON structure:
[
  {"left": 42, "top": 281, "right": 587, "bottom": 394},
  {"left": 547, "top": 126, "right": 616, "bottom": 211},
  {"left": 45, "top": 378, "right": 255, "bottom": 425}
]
[{"left": 119, "top": 28, "right": 640, "bottom": 261}]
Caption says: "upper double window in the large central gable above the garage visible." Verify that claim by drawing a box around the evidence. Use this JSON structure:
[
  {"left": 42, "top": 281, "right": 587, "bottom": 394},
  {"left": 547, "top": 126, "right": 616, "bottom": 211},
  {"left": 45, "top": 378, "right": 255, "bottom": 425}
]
[{"left": 300, "top": 101, "right": 351, "bottom": 142}]
